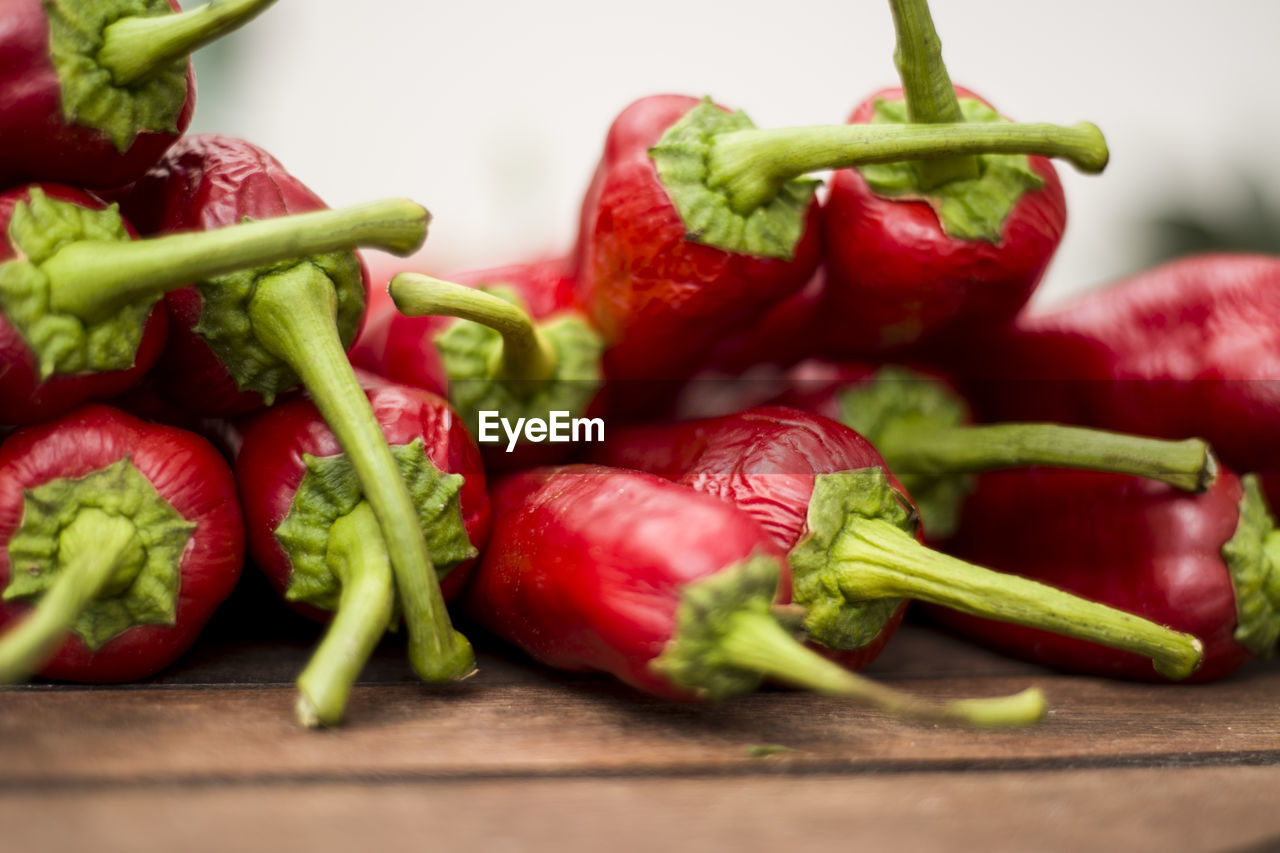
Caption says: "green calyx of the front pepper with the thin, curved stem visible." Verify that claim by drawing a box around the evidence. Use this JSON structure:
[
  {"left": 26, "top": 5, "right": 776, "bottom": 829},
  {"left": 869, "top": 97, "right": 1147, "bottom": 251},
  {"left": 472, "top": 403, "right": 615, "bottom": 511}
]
[{"left": 649, "top": 555, "right": 782, "bottom": 702}]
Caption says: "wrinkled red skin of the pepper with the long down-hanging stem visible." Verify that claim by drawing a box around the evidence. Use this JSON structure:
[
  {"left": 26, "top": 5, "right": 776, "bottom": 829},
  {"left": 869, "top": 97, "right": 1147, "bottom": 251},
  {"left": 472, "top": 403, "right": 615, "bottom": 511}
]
[{"left": 116, "top": 133, "right": 369, "bottom": 416}]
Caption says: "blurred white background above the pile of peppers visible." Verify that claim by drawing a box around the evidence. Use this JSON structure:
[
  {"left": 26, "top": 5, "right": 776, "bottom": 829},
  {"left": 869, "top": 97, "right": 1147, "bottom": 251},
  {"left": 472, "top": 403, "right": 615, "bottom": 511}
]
[{"left": 184, "top": 0, "right": 1280, "bottom": 300}]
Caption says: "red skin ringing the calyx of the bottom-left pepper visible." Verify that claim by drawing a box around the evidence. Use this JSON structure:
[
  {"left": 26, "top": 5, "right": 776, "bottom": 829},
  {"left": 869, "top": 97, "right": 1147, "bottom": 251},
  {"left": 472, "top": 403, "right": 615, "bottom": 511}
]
[{"left": 0, "top": 403, "right": 244, "bottom": 683}]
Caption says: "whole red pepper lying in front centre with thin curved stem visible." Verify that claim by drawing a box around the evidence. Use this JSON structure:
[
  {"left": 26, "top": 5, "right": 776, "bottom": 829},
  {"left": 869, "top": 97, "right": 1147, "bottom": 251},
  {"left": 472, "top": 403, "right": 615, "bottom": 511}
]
[{"left": 467, "top": 465, "right": 1044, "bottom": 725}]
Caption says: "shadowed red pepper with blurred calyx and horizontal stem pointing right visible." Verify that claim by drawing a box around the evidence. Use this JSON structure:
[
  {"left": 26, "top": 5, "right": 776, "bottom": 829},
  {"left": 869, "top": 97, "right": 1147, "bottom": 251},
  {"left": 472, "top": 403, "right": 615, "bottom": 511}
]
[{"left": 776, "top": 361, "right": 1217, "bottom": 540}]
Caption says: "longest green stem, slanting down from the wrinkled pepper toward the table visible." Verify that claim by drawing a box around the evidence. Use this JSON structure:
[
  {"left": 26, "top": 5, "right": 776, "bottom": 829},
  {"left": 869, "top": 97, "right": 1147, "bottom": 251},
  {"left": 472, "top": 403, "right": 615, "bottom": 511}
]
[{"left": 248, "top": 263, "right": 475, "bottom": 681}]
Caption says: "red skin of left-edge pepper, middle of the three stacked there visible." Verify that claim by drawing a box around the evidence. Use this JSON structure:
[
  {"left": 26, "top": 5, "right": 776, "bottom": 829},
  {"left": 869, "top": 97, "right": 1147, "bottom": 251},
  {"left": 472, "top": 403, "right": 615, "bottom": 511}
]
[{"left": 0, "top": 183, "right": 169, "bottom": 424}]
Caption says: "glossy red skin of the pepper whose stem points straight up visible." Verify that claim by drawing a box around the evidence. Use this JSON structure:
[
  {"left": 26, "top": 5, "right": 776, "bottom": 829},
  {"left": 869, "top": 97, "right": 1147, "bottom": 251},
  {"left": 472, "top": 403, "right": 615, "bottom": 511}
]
[{"left": 812, "top": 87, "right": 1066, "bottom": 357}]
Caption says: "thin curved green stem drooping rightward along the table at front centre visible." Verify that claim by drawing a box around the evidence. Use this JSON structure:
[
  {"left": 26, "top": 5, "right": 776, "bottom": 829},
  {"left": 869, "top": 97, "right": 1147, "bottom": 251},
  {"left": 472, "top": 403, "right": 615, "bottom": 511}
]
[{"left": 718, "top": 610, "right": 1047, "bottom": 727}]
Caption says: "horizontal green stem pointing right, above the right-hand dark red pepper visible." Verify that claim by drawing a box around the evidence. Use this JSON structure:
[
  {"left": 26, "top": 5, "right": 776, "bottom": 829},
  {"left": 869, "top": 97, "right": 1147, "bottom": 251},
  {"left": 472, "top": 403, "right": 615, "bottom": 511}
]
[{"left": 876, "top": 421, "right": 1217, "bottom": 492}]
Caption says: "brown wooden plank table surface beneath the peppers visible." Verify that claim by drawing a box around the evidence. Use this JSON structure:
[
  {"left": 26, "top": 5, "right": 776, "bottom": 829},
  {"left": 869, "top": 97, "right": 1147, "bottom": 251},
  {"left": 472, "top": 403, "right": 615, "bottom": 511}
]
[{"left": 0, "top": 573, "right": 1280, "bottom": 853}]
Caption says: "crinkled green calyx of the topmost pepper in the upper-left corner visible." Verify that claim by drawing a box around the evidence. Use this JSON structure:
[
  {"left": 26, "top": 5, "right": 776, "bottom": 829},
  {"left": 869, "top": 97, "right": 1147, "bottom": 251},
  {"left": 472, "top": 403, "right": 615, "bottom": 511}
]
[{"left": 41, "top": 0, "right": 187, "bottom": 151}]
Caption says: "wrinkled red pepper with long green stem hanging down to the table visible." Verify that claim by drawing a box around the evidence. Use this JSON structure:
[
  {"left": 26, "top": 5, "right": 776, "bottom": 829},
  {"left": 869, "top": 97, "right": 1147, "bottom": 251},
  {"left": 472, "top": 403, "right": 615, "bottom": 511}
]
[{"left": 111, "top": 136, "right": 475, "bottom": 680}]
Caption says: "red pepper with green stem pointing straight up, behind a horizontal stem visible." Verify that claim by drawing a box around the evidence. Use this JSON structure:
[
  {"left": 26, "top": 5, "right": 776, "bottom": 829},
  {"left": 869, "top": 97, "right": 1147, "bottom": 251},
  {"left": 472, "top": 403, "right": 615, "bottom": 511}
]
[{"left": 810, "top": 0, "right": 1085, "bottom": 356}]
